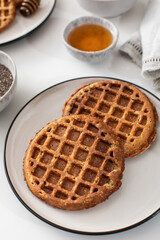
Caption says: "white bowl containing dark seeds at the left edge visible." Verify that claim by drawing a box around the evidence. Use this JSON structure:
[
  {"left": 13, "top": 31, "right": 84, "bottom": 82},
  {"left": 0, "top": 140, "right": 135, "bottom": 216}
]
[{"left": 0, "top": 51, "right": 17, "bottom": 112}]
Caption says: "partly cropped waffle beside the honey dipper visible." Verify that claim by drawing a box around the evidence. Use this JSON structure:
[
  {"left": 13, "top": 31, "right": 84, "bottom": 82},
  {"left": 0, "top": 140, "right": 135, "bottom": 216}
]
[{"left": 0, "top": 0, "right": 16, "bottom": 32}]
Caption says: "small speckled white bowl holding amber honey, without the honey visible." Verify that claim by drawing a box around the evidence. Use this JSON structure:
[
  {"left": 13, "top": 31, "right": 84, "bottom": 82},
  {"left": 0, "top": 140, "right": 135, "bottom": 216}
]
[{"left": 63, "top": 16, "right": 119, "bottom": 63}]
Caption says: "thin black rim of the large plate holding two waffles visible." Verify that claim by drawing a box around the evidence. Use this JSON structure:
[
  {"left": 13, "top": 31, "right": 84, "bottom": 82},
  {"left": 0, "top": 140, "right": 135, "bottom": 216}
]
[{"left": 4, "top": 76, "right": 160, "bottom": 235}]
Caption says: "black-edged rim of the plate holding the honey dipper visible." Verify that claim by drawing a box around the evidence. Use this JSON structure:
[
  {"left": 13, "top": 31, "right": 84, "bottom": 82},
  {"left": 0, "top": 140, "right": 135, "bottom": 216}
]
[{"left": 0, "top": 0, "right": 57, "bottom": 46}]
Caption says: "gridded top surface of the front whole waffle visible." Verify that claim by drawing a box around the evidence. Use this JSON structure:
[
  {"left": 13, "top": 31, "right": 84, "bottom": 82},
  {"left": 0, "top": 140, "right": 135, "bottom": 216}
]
[{"left": 26, "top": 118, "right": 122, "bottom": 201}]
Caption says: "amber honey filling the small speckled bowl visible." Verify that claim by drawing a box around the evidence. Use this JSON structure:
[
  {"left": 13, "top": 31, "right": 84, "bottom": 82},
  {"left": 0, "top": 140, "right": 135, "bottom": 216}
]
[{"left": 67, "top": 24, "right": 113, "bottom": 52}]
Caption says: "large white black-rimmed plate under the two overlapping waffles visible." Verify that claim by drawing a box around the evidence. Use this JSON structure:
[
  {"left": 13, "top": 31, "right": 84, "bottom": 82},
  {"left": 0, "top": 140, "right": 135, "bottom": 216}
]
[{"left": 5, "top": 77, "right": 160, "bottom": 234}]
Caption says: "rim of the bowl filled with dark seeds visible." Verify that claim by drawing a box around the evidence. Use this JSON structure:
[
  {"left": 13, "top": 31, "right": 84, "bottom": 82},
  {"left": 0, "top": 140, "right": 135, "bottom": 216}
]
[{"left": 0, "top": 50, "right": 17, "bottom": 101}]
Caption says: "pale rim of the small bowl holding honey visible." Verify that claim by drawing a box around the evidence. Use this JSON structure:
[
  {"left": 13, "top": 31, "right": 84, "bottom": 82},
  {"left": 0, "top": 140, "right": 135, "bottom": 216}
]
[{"left": 63, "top": 16, "right": 119, "bottom": 55}]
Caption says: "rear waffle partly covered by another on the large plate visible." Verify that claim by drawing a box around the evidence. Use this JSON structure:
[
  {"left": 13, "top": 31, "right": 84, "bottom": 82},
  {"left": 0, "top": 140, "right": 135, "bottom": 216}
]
[{"left": 63, "top": 79, "right": 158, "bottom": 158}]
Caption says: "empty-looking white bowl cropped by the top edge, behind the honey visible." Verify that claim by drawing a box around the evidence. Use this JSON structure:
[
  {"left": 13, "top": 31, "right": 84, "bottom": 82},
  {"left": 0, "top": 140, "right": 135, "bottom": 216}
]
[{"left": 77, "top": 0, "right": 137, "bottom": 18}]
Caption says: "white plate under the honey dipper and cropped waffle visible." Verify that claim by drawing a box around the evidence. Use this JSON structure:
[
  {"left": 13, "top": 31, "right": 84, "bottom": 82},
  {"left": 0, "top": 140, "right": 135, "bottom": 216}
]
[{"left": 0, "top": 0, "right": 56, "bottom": 45}]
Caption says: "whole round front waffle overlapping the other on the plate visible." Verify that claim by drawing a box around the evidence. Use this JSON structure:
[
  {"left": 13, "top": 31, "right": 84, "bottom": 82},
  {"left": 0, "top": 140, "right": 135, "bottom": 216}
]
[{"left": 24, "top": 115, "right": 124, "bottom": 210}]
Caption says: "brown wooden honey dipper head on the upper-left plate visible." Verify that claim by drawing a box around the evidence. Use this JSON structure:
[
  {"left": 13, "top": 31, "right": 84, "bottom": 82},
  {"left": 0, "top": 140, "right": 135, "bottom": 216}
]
[{"left": 19, "top": 0, "right": 40, "bottom": 17}]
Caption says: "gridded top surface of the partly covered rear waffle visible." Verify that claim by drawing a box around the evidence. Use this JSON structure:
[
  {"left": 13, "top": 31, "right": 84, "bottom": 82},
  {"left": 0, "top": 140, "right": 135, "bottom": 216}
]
[{"left": 64, "top": 82, "right": 150, "bottom": 149}]
